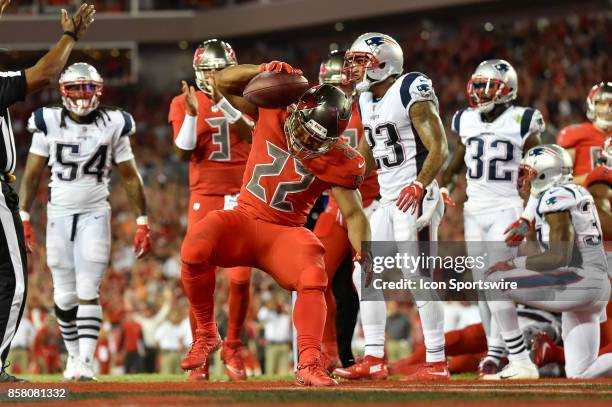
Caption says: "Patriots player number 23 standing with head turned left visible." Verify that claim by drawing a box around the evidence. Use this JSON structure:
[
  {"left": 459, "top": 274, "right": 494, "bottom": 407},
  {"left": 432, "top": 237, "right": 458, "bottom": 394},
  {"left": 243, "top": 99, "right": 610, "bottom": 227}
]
[{"left": 334, "top": 33, "right": 450, "bottom": 380}]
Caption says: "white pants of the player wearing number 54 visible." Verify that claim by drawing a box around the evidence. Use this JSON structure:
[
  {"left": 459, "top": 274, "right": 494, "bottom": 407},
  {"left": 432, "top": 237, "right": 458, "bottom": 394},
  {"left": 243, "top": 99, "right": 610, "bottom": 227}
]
[{"left": 47, "top": 209, "right": 111, "bottom": 310}]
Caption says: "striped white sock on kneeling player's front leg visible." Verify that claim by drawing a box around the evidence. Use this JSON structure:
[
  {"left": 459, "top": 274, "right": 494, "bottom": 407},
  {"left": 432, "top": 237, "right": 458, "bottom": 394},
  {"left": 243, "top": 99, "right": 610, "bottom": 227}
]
[{"left": 489, "top": 300, "right": 529, "bottom": 361}]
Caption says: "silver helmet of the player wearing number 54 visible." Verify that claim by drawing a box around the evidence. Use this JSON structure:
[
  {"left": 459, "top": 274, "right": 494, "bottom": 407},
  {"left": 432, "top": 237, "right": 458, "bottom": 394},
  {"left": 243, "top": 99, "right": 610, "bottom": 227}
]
[{"left": 59, "top": 62, "right": 104, "bottom": 116}]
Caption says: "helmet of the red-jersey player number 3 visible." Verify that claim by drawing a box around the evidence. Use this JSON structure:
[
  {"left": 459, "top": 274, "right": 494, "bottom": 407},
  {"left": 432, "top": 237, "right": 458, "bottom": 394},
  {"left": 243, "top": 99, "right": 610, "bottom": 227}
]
[{"left": 193, "top": 39, "right": 238, "bottom": 95}]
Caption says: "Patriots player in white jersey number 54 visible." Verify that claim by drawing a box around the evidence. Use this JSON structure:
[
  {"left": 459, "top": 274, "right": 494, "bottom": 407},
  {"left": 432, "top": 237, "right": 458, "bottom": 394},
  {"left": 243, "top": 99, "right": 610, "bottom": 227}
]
[{"left": 19, "top": 63, "right": 151, "bottom": 381}]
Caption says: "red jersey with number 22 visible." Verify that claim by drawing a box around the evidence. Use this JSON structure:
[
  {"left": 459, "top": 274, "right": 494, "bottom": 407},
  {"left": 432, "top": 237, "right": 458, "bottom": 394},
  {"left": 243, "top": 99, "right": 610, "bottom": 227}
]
[{"left": 238, "top": 109, "right": 365, "bottom": 226}]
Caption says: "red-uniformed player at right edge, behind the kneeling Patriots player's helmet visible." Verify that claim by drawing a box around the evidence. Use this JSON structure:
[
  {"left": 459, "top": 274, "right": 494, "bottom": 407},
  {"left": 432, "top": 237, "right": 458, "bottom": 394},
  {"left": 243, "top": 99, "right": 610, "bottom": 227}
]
[{"left": 557, "top": 82, "right": 612, "bottom": 184}]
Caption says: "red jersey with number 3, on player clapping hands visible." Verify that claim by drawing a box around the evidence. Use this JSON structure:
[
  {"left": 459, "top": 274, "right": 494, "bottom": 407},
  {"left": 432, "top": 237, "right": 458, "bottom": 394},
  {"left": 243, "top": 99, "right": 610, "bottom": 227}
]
[{"left": 168, "top": 91, "right": 251, "bottom": 195}]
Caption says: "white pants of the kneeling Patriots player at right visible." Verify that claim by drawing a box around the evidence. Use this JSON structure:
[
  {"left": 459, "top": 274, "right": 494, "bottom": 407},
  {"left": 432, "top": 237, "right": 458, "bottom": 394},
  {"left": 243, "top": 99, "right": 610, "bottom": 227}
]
[{"left": 486, "top": 269, "right": 610, "bottom": 378}]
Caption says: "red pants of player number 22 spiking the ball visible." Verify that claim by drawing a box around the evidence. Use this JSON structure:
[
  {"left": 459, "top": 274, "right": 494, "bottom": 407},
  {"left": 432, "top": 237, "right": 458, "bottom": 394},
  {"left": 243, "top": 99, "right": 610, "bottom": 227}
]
[{"left": 181, "top": 209, "right": 327, "bottom": 363}]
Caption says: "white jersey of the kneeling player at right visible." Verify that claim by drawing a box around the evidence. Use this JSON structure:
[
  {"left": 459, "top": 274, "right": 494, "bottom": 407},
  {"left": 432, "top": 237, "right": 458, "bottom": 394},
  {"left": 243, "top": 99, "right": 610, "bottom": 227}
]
[{"left": 535, "top": 184, "right": 610, "bottom": 273}]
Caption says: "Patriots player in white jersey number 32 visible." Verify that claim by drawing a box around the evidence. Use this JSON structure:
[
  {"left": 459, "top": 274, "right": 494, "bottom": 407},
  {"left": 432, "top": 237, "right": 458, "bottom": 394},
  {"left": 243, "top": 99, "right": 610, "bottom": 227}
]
[{"left": 442, "top": 59, "right": 545, "bottom": 375}]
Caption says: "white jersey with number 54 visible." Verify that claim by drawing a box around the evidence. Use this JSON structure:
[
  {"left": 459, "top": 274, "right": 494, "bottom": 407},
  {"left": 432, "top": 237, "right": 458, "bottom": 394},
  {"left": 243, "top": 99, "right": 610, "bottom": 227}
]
[{"left": 28, "top": 107, "right": 136, "bottom": 216}]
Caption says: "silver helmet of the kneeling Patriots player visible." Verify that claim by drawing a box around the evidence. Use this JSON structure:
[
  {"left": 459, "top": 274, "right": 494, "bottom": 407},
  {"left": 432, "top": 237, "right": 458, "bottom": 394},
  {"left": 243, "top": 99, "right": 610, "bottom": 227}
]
[{"left": 519, "top": 144, "right": 573, "bottom": 197}]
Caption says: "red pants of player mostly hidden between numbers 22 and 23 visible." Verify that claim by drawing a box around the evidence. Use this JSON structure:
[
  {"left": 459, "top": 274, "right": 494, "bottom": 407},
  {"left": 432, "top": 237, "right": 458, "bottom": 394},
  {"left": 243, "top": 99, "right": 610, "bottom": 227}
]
[{"left": 314, "top": 209, "right": 352, "bottom": 358}]
